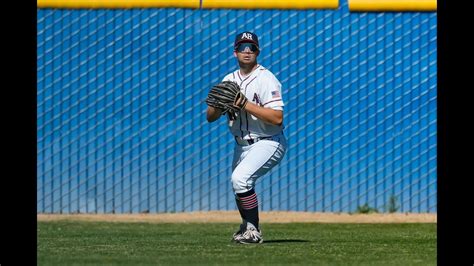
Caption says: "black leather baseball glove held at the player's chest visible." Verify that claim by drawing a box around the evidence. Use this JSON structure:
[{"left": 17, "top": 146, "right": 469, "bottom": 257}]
[{"left": 206, "top": 81, "right": 248, "bottom": 113}]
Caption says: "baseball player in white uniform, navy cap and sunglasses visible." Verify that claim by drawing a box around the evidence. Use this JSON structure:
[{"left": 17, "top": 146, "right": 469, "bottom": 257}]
[{"left": 207, "top": 32, "right": 287, "bottom": 244}]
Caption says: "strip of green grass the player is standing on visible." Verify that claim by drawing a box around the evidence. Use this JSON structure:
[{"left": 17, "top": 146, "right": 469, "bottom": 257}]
[{"left": 37, "top": 221, "right": 436, "bottom": 265}]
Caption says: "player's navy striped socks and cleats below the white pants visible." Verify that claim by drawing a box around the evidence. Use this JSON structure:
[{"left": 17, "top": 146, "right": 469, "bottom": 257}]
[{"left": 233, "top": 189, "right": 263, "bottom": 244}]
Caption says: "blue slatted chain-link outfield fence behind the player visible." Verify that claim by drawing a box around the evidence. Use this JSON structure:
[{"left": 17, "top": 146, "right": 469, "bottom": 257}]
[{"left": 37, "top": 4, "right": 437, "bottom": 213}]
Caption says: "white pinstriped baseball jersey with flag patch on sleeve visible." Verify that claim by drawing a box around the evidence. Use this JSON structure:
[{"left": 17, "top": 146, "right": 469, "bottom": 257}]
[{"left": 222, "top": 65, "right": 284, "bottom": 140}]
